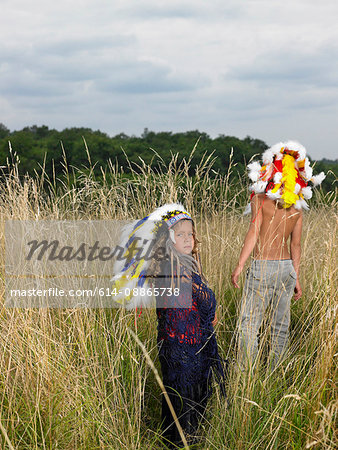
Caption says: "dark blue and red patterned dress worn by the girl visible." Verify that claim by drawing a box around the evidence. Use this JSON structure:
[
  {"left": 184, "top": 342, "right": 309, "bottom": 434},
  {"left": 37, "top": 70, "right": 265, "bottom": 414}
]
[{"left": 157, "top": 264, "right": 225, "bottom": 445}]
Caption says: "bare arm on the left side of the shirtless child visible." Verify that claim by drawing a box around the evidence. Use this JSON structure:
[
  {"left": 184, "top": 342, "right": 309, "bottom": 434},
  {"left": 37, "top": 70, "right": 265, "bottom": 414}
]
[{"left": 231, "top": 195, "right": 263, "bottom": 288}]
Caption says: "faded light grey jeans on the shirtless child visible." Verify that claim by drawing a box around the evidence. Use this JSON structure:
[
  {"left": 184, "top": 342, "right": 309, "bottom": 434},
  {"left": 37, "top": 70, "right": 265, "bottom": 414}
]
[{"left": 238, "top": 259, "right": 297, "bottom": 370}]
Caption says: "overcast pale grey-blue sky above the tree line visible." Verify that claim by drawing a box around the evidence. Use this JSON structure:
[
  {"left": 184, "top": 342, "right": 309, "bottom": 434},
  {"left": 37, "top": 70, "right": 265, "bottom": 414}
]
[{"left": 0, "top": 0, "right": 338, "bottom": 159}]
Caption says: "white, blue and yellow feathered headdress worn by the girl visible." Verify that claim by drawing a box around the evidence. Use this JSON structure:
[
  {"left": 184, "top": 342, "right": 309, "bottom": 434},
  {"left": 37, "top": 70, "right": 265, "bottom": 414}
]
[{"left": 111, "top": 203, "right": 192, "bottom": 309}]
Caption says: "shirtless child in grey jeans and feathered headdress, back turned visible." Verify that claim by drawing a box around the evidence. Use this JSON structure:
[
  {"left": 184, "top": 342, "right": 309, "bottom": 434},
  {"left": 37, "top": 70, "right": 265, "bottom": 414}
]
[{"left": 231, "top": 142, "right": 324, "bottom": 369}]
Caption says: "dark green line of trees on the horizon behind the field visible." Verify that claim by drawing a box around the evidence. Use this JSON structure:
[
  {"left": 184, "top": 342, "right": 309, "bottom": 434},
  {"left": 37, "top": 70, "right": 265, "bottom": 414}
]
[{"left": 0, "top": 124, "right": 338, "bottom": 191}]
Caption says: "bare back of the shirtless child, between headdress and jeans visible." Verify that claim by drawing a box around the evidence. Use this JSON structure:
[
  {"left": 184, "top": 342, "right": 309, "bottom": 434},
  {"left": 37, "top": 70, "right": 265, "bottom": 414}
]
[{"left": 253, "top": 194, "right": 300, "bottom": 260}]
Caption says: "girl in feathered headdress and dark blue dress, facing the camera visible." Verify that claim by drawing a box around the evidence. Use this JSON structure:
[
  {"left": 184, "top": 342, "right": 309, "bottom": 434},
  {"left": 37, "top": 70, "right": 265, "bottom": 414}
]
[{"left": 113, "top": 204, "right": 225, "bottom": 448}]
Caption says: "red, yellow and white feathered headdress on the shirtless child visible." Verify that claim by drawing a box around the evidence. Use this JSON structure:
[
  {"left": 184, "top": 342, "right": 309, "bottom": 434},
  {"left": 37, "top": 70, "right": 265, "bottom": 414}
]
[{"left": 246, "top": 141, "right": 325, "bottom": 213}]
